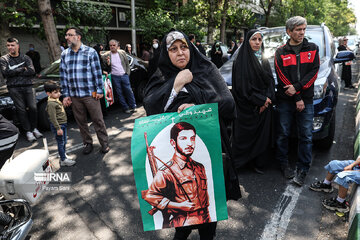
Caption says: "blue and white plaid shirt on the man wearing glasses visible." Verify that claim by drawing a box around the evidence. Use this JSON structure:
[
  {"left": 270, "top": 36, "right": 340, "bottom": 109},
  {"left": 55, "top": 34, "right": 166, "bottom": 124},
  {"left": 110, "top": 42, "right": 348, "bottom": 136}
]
[{"left": 60, "top": 44, "right": 104, "bottom": 97}]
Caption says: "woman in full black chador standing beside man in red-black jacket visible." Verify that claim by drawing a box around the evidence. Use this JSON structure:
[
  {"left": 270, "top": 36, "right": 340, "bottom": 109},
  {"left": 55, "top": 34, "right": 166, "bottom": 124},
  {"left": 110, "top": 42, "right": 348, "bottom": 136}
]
[{"left": 232, "top": 29, "right": 275, "bottom": 173}]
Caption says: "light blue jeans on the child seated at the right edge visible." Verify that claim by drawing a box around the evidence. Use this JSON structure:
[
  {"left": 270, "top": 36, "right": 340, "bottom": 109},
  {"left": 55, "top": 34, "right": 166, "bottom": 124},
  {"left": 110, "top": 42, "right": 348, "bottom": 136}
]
[{"left": 324, "top": 160, "right": 360, "bottom": 188}]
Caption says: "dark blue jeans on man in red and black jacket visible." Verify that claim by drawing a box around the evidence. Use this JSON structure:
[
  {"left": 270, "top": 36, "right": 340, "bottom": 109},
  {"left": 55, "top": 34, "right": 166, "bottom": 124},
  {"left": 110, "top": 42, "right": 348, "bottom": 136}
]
[{"left": 276, "top": 102, "right": 314, "bottom": 173}]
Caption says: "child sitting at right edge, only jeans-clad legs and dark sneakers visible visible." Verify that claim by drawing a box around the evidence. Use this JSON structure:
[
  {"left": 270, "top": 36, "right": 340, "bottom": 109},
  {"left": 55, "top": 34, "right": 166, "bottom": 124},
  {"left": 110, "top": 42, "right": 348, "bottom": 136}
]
[{"left": 309, "top": 156, "right": 360, "bottom": 213}]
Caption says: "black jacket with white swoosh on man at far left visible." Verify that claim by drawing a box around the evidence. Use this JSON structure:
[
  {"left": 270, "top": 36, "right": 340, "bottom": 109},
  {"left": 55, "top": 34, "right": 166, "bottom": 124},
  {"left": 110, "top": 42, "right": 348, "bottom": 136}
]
[{"left": 0, "top": 54, "right": 35, "bottom": 88}]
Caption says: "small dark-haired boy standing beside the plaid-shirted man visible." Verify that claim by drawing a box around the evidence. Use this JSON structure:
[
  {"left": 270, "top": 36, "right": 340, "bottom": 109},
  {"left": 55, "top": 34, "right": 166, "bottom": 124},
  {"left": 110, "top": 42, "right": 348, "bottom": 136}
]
[{"left": 44, "top": 81, "right": 76, "bottom": 166}]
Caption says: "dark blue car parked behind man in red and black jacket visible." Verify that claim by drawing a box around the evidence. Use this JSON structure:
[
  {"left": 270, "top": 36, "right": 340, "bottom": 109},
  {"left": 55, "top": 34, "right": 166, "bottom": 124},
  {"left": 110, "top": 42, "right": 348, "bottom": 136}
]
[{"left": 220, "top": 24, "right": 354, "bottom": 148}]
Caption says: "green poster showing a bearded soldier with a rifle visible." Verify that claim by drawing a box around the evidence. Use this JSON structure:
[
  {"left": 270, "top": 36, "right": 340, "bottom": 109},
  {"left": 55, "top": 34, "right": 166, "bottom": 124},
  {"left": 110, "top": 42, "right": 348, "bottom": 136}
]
[{"left": 131, "top": 103, "right": 228, "bottom": 231}]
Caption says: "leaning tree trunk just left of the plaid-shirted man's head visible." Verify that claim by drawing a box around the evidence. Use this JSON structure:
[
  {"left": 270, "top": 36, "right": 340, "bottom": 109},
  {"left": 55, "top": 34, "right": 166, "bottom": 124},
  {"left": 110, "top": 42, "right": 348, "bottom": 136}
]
[{"left": 38, "top": 0, "right": 61, "bottom": 62}]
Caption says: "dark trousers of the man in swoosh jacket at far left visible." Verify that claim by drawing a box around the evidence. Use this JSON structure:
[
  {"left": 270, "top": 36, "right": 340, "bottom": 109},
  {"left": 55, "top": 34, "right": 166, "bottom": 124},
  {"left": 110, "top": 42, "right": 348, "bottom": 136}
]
[{"left": 8, "top": 86, "right": 37, "bottom": 132}]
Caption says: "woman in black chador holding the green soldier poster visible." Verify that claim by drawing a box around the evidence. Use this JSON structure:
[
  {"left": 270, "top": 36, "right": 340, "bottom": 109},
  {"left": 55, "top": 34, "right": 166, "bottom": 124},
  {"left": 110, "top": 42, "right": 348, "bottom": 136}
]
[{"left": 144, "top": 31, "right": 241, "bottom": 239}]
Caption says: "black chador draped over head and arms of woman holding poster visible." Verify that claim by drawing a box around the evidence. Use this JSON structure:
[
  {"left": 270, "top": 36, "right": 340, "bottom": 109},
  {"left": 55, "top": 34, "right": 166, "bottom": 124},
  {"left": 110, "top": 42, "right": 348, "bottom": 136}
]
[{"left": 144, "top": 30, "right": 235, "bottom": 119}]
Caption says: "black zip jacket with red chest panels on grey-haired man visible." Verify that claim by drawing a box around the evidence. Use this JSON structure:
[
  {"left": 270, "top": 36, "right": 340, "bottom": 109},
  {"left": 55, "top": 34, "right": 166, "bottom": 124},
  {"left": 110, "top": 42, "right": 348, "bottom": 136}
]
[{"left": 275, "top": 38, "right": 320, "bottom": 104}]
